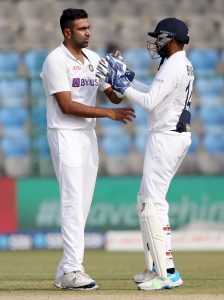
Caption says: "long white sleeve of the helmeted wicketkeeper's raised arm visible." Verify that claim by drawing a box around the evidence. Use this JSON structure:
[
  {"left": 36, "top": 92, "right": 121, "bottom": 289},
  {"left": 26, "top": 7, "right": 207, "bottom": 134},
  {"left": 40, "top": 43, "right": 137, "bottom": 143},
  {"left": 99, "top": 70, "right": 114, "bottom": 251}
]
[{"left": 124, "top": 68, "right": 177, "bottom": 111}]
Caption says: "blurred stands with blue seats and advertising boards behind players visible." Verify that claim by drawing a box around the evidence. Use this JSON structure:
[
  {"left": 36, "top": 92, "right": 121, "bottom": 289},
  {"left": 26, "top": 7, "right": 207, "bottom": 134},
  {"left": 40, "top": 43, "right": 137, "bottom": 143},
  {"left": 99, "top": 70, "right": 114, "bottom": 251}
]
[{"left": 0, "top": 0, "right": 224, "bottom": 250}]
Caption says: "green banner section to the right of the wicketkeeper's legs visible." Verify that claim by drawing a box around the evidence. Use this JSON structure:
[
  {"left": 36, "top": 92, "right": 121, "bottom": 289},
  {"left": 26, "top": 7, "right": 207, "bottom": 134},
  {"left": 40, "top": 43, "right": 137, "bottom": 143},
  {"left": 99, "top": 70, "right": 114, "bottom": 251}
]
[{"left": 167, "top": 176, "right": 224, "bottom": 229}]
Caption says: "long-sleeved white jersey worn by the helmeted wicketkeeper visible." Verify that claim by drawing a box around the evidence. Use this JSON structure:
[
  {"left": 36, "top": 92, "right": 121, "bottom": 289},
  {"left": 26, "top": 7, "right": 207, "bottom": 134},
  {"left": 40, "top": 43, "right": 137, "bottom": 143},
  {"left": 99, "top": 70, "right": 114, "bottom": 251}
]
[{"left": 124, "top": 50, "right": 194, "bottom": 132}]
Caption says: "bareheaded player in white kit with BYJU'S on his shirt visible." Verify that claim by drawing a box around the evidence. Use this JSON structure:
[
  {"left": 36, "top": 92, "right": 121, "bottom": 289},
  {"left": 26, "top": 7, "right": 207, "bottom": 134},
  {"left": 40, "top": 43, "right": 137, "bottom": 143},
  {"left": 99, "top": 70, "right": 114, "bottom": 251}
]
[{"left": 41, "top": 9, "right": 135, "bottom": 290}]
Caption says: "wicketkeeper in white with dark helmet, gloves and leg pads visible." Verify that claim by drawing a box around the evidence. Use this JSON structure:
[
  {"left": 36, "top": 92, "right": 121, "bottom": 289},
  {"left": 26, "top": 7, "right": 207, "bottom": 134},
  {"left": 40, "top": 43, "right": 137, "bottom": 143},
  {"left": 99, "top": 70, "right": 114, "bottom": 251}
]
[{"left": 97, "top": 18, "right": 194, "bottom": 290}]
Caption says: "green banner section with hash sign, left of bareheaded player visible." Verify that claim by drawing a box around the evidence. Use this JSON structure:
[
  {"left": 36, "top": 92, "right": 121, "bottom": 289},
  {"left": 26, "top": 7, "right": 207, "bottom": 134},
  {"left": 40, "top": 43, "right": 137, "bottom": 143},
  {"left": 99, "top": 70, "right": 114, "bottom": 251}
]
[{"left": 17, "top": 178, "right": 60, "bottom": 231}]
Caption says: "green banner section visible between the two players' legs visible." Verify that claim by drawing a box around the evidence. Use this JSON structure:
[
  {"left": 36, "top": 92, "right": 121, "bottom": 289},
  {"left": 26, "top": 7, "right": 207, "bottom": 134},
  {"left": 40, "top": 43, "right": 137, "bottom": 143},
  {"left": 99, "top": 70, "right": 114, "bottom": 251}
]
[{"left": 87, "top": 177, "right": 140, "bottom": 231}]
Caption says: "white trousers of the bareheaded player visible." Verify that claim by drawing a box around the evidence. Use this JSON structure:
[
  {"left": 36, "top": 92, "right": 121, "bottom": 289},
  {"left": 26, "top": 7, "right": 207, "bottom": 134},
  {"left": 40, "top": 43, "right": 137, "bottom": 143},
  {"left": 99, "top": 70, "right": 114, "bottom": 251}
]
[{"left": 47, "top": 129, "right": 99, "bottom": 279}]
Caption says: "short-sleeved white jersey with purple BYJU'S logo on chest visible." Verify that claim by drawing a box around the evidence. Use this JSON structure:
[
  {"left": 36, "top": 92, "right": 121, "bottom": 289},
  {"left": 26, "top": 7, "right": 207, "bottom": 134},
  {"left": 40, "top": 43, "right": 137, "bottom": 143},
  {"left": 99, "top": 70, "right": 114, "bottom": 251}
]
[{"left": 41, "top": 43, "right": 107, "bottom": 129}]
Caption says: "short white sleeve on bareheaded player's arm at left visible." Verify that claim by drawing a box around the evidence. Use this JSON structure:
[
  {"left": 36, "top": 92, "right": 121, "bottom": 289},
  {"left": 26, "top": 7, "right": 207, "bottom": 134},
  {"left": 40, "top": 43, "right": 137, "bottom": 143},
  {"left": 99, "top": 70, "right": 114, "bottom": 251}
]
[{"left": 41, "top": 57, "right": 71, "bottom": 95}]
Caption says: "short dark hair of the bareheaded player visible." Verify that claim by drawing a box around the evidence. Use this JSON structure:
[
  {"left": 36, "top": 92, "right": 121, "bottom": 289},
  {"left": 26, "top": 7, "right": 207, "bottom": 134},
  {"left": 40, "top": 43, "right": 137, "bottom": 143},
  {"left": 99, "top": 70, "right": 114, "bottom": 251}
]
[{"left": 60, "top": 8, "right": 88, "bottom": 32}]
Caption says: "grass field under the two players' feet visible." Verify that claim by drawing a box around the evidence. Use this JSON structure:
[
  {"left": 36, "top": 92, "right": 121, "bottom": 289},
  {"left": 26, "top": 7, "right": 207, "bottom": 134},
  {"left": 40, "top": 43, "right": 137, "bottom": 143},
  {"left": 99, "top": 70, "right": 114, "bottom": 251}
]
[{"left": 0, "top": 250, "right": 224, "bottom": 300}]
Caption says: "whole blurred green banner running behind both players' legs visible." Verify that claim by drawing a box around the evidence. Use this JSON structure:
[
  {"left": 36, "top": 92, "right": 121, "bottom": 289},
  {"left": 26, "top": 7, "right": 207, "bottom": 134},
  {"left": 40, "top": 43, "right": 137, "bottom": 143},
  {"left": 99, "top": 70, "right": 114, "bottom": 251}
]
[{"left": 17, "top": 176, "right": 224, "bottom": 231}]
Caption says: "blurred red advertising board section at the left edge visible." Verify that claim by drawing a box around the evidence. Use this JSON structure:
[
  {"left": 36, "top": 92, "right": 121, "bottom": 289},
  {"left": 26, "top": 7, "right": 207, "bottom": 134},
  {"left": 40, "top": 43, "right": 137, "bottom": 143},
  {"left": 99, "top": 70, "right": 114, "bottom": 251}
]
[{"left": 0, "top": 178, "right": 17, "bottom": 233}]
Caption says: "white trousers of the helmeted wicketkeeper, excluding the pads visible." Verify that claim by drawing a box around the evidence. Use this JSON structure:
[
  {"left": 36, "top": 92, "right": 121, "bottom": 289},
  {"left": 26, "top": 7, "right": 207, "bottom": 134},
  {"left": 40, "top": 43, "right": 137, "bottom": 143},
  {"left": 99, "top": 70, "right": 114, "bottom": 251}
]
[{"left": 138, "top": 132, "right": 191, "bottom": 267}]
